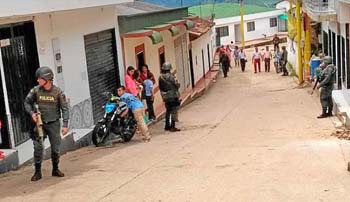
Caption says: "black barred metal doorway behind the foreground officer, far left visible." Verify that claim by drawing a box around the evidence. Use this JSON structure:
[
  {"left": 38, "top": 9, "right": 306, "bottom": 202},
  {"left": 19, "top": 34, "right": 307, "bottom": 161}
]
[{"left": 0, "top": 21, "right": 39, "bottom": 148}]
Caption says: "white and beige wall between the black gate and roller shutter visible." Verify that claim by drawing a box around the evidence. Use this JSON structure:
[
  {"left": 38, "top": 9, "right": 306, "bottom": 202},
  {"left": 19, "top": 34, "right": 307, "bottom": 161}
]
[{"left": 34, "top": 7, "right": 121, "bottom": 106}]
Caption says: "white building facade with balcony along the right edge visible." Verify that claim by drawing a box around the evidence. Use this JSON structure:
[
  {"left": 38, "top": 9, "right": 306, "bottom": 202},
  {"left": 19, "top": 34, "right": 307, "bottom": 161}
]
[{"left": 303, "top": 0, "right": 350, "bottom": 126}]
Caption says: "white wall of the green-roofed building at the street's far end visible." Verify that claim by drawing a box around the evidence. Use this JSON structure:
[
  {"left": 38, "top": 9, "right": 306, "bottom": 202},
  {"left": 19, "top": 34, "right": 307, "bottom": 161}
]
[{"left": 215, "top": 9, "right": 285, "bottom": 45}]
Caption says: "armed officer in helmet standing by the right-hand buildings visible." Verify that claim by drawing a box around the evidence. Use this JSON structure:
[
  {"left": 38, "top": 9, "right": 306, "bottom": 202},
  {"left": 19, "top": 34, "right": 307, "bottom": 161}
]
[{"left": 317, "top": 56, "right": 336, "bottom": 119}]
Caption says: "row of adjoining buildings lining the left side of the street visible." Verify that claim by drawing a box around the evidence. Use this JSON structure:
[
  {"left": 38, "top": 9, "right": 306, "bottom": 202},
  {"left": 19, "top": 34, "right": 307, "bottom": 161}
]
[{"left": 0, "top": 0, "right": 215, "bottom": 173}]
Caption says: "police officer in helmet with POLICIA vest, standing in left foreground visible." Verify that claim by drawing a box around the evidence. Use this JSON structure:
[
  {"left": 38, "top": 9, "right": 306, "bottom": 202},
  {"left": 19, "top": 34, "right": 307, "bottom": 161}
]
[{"left": 24, "top": 67, "right": 69, "bottom": 181}]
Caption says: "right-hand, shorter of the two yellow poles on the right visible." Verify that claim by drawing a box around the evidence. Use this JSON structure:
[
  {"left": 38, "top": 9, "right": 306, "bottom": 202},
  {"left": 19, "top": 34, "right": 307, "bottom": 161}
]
[{"left": 304, "top": 14, "right": 311, "bottom": 78}]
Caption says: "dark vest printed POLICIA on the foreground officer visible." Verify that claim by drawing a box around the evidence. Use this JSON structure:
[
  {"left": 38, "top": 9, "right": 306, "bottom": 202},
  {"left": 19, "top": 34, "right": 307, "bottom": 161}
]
[{"left": 35, "top": 86, "right": 61, "bottom": 122}]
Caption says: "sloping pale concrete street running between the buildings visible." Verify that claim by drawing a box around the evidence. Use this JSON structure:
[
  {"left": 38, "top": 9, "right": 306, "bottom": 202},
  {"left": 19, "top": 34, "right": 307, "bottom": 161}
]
[{"left": 0, "top": 51, "right": 350, "bottom": 202}]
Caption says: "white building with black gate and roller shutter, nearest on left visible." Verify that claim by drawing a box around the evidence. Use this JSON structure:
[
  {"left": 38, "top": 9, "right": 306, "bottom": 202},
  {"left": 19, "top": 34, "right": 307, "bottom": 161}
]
[{"left": 0, "top": 0, "right": 131, "bottom": 170}]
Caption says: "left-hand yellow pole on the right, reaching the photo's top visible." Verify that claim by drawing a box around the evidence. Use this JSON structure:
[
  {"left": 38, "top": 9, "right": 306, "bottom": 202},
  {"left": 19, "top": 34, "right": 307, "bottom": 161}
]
[{"left": 296, "top": 0, "right": 304, "bottom": 84}]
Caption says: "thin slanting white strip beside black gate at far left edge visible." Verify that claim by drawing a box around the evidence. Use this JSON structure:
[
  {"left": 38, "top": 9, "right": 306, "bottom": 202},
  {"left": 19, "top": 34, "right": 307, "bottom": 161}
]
[{"left": 0, "top": 44, "right": 16, "bottom": 149}]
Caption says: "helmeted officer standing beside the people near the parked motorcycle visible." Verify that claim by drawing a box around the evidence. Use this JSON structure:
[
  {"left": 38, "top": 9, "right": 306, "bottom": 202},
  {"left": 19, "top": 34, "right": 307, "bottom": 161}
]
[{"left": 159, "top": 63, "right": 180, "bottom": 132}]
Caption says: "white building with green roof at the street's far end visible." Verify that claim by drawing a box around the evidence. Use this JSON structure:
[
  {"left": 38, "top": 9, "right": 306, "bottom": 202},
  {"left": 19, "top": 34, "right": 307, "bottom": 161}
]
[{"left": 189, "top": 3, "right": 286, "bottom": 46}]
